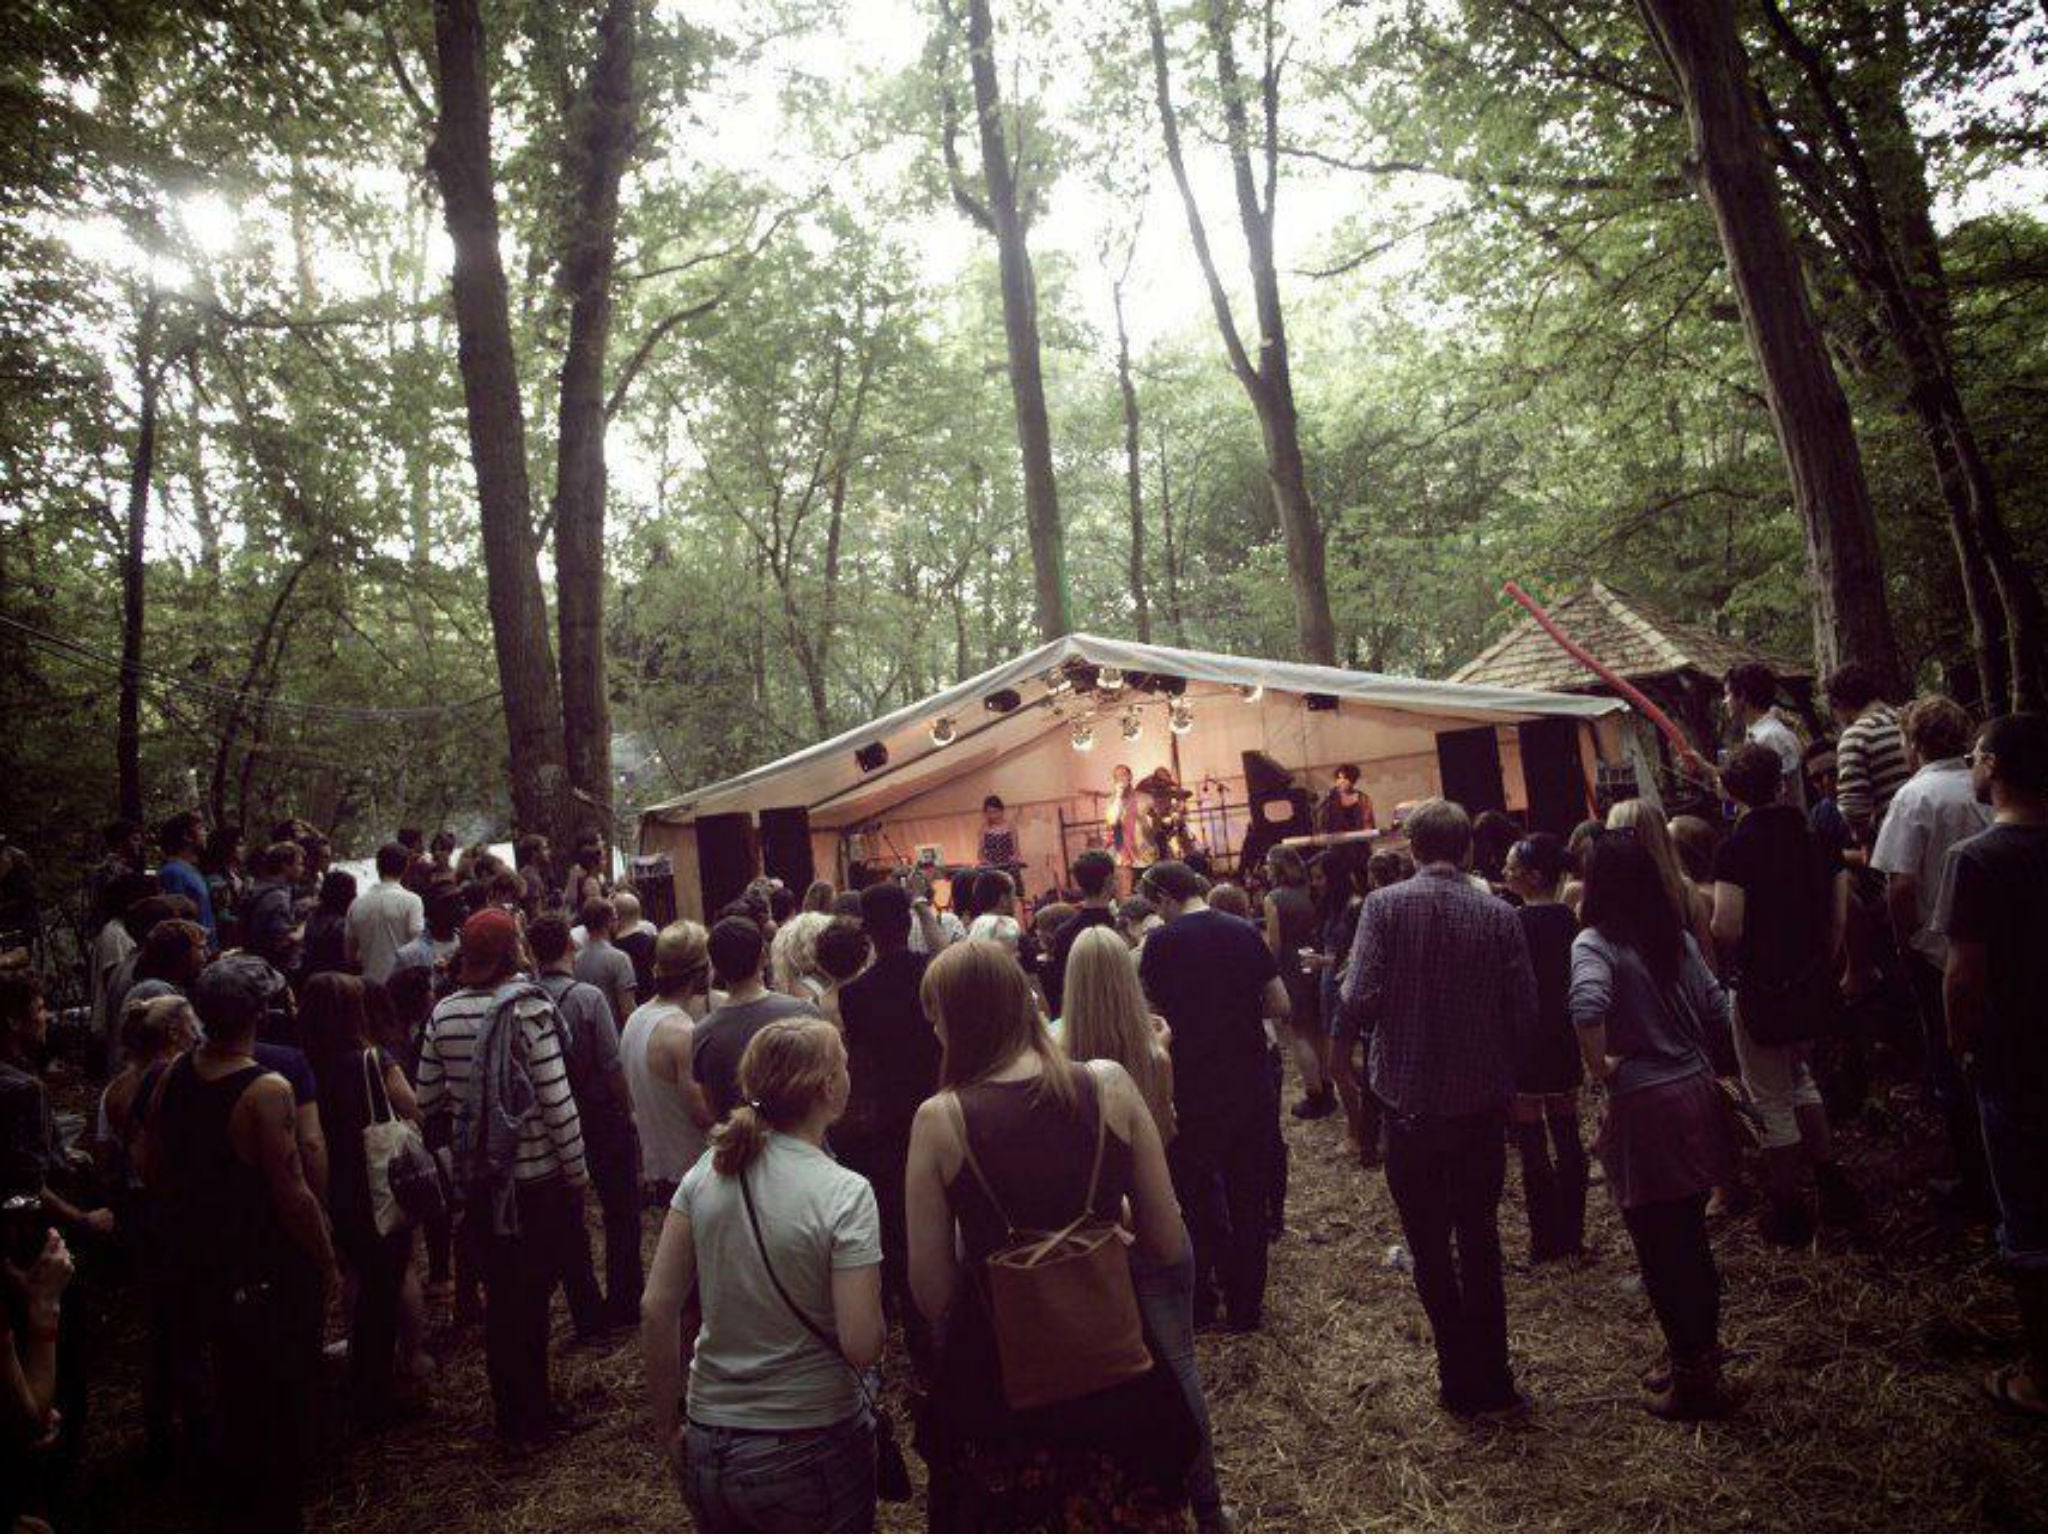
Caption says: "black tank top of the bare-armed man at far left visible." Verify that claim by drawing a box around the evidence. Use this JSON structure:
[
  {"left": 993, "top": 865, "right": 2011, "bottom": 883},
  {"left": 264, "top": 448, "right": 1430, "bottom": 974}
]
[{"left": 158, "top": 1055, "right": 311, "bottom": 1294}]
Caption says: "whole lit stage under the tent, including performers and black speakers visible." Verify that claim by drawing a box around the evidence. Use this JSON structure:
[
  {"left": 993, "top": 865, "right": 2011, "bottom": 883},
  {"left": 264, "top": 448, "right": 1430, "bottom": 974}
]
[{"left": 637, "top": 635, "right": 1626, "bottom": 918}]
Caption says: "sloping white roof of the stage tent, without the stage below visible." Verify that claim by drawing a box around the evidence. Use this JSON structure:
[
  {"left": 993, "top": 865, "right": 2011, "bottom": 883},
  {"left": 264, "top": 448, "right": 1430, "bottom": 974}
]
[{"left": 641, "top": 635, "right": 1622, "bottom": 823}]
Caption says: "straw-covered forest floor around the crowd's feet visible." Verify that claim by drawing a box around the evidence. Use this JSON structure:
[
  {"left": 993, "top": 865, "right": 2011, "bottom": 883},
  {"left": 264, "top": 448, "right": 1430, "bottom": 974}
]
[{"left": 48, "top": 1073, "right": 2048, "bottom": 1530}]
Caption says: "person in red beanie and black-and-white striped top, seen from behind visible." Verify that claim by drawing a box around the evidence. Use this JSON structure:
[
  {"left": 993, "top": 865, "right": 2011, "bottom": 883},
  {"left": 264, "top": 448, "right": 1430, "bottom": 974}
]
[{"left": 420, "top": 907, "right": 590, "bottom": 1448}]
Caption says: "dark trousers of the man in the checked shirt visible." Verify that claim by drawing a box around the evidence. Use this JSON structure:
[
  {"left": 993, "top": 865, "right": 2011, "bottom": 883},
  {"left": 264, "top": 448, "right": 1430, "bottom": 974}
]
[{"left": 1386, "top": 1112, "right": 1516, "bottom": 1413}]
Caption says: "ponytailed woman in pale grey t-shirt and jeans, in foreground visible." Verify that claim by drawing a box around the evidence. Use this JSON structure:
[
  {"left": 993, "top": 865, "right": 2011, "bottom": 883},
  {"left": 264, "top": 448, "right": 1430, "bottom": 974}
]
[{"left": 641, "top": 1018, "right": 885, "bottom": 1532}]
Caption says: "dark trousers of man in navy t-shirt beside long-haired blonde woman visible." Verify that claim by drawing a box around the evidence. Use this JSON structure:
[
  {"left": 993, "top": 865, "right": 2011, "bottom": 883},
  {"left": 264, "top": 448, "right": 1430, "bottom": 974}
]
[{"left": 1167, "top": 1085, "right": 1280, "bottom": 1327}]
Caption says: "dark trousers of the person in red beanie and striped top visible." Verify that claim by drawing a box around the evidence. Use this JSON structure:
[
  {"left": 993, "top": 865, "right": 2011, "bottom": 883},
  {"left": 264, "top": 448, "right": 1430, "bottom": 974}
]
[{"left": 467, "top": 1180, "right": 573, "bottom": 1440}]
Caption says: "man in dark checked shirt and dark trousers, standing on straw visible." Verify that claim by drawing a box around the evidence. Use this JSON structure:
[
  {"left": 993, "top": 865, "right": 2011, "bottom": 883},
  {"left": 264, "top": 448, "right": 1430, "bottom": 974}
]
[{"left": 1343, "top": 801, "right": 1536, "bottom": 1417}]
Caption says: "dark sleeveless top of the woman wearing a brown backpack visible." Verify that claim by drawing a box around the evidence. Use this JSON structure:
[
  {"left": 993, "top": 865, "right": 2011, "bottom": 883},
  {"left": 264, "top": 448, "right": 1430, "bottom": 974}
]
[{"left": 948, "top": 1067, "right": 1130, "bottom": 1264}]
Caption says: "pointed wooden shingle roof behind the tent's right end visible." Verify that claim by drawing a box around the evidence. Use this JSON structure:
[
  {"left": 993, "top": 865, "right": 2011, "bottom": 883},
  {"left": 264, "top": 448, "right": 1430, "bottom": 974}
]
[{"left": 1450, "top": 582, "right": 1812, "bottom": 692}]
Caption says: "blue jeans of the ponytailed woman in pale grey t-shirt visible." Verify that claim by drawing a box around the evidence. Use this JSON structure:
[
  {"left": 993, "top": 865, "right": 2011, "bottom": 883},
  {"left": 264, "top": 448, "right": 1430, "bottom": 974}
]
[{"left": 682, "top": 1411, "right": 874, "bottom": 1532}]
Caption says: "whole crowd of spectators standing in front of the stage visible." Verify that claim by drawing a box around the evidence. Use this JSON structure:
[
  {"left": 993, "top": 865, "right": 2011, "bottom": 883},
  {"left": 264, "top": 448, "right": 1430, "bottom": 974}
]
[{"left": 0, "top": 666, "right": 2048, "bottom": 1530}]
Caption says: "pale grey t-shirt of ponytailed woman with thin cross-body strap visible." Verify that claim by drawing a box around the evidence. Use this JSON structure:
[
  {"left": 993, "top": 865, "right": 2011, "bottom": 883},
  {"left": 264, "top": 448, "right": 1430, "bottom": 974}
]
[{"left": 672, "top": 1133, "right": 883, "bottom": 1430}]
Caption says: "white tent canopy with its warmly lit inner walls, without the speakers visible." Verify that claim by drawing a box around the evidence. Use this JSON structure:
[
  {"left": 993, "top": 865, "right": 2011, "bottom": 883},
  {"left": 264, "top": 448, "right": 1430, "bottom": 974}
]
[{"left": 639, "top": 635, "right": 1622, "bottom": 915}]
